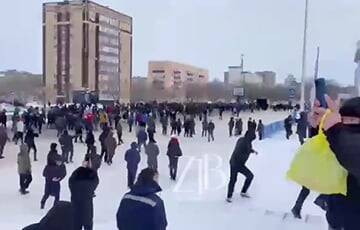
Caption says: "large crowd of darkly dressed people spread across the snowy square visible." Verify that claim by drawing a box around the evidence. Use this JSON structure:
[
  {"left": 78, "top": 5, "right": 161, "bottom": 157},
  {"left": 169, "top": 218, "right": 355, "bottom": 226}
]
[{"left": 0, "top": 98, "right": 360, "bottom": 230}]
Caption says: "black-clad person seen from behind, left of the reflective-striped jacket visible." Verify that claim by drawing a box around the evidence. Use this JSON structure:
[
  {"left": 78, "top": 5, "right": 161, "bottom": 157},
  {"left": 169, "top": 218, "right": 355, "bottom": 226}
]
[{"left": 69, "top": 155, "right": 101, "bottom": 230}]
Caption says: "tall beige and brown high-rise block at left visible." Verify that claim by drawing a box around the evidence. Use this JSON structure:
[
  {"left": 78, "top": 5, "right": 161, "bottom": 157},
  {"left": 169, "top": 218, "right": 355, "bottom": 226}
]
[{"left": 43, "top": 0, "right": 132, "bottom": 103}]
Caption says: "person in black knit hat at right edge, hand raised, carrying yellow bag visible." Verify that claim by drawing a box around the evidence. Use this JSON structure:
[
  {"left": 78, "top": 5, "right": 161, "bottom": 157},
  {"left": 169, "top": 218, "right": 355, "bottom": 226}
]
[{"left": 311, "top": 96, "right": 360, "bottom": 230}]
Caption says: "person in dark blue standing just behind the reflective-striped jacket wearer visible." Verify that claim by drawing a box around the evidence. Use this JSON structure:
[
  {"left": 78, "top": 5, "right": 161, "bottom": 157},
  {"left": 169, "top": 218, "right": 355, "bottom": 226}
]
[{"left": 125, "top": 142, "right": 140, "bottom": 188}]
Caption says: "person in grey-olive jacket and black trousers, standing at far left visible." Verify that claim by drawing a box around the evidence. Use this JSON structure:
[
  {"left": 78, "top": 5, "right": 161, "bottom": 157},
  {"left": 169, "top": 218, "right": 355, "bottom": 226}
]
[{"left": 17, "top": 144, "right": 32, "bottom": 195}]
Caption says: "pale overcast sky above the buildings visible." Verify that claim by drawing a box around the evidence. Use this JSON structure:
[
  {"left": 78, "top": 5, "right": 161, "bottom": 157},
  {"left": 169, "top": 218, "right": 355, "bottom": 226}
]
[{"left": 0, "top": 0, "right": 360, "bottom": 84}]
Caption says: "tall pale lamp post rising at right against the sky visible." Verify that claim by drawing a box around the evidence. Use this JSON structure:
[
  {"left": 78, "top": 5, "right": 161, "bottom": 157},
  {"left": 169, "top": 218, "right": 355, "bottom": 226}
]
[{"left": 300, "top": 0, "right": 309, "bottom": 111}]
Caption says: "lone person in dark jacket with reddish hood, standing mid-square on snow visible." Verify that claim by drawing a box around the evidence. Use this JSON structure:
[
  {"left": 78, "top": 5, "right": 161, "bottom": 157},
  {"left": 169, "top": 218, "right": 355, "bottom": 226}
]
[{"left": 166, "top": 136, "right": 182, "bottom": 180}]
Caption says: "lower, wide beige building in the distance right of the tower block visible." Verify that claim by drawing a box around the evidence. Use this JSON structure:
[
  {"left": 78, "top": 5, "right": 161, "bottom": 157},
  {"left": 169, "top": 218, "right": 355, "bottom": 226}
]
[{"left": 148, "top": 61, "right": 209, "bottom": 101}]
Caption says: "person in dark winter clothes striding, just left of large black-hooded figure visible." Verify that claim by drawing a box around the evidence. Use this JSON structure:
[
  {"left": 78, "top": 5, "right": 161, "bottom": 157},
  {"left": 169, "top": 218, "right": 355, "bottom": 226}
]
[{"left": 41, "top": 155, "right": 66, "bottom": 209}]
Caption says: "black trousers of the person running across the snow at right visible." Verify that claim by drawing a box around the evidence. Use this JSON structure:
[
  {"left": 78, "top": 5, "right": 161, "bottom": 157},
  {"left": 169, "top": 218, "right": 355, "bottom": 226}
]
[{"left": 227, "top": 165, "right": 254, "bottom": 198}]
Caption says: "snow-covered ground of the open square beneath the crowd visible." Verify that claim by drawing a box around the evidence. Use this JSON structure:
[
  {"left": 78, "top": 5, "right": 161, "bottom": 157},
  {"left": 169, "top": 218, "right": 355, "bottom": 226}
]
[{"left": 0, "top": 112, "right": 326, "bottom": 230}]
